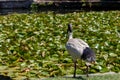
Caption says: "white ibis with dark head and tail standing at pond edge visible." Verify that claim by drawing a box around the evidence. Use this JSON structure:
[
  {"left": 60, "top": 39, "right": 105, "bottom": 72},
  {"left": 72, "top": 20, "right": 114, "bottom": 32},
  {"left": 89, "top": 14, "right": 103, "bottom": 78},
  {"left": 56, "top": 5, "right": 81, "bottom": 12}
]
[{"left": 66, "top": 23, "right": 96, "bottom": 78}]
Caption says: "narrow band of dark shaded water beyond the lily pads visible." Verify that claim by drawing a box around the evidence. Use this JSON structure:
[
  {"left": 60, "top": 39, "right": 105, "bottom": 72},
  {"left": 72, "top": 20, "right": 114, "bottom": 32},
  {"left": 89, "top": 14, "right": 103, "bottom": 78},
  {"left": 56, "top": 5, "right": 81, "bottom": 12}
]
[{"left": 0, "top": 7, "right": 120, "bottom": 15}]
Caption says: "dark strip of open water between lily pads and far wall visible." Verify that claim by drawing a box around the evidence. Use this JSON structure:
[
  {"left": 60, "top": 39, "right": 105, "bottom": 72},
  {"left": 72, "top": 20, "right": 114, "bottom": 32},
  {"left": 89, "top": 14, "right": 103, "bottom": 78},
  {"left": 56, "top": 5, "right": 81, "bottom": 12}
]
[{"left": 0, "top": 5, "right": 120, "bottom": 15}]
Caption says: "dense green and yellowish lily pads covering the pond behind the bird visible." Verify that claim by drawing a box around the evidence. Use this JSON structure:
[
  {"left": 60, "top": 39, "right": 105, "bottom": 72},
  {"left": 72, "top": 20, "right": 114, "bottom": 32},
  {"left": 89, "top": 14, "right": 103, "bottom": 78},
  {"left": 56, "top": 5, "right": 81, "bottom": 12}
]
[{"left": 0, "top": 11, "right": 120, "bottom": 79}]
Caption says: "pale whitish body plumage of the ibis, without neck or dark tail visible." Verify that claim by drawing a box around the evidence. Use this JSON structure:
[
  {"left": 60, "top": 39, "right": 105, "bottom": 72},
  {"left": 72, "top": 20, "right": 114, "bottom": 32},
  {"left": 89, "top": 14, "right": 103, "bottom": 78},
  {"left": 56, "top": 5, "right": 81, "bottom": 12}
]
[{"left": 66, "top": 38, "right": 89, "bottom": 60}]
